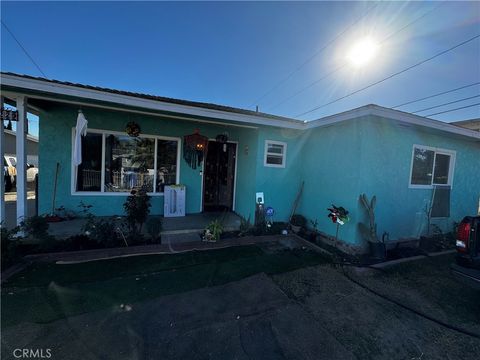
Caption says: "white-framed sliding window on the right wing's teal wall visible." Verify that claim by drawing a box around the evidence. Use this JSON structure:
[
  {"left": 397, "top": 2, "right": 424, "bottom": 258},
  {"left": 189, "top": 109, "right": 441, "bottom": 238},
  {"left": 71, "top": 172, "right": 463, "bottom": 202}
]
[{"left": 410, "top": 145, "right": 456, "bottom": 188}]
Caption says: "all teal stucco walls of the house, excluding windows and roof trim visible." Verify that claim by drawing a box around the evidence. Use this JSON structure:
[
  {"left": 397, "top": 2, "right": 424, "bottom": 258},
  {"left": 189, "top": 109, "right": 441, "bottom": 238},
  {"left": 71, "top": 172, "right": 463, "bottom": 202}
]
[{"left": 39, "top": 105, "right": 480, "bottom": 250}]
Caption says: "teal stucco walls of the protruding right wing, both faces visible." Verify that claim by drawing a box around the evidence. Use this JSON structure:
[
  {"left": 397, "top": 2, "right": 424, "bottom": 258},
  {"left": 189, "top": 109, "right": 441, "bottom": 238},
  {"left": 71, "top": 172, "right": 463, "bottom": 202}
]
[{"left": 298, "top": 117, "right": 480, "bottom": 247}]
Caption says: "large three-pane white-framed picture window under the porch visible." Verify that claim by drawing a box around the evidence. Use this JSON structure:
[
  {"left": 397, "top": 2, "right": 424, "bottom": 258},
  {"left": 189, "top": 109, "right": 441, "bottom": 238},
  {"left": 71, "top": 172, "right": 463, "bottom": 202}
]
[{"left": 74, "top": 130, "right": 180, "bottom": 193}]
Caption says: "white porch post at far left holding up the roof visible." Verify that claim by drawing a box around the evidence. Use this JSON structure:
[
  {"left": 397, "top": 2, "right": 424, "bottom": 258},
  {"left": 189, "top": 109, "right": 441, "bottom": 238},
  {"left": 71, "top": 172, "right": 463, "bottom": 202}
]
[{"left": 16, "top": 96, "right": 27, "bottom": 225}]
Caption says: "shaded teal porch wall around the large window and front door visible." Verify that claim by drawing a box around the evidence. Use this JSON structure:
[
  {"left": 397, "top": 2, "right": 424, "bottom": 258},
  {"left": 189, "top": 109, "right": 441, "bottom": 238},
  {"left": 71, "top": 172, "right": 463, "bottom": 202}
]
[{"left": 39, "top": 102, "right": 258, "bottom": 216}]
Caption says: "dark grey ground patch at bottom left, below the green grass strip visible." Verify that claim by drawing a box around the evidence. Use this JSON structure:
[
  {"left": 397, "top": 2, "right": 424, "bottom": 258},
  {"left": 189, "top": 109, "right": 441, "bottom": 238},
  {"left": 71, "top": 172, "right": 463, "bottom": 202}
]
[{"left": 2, "top": 274, "right": 355, "bottom": 360}]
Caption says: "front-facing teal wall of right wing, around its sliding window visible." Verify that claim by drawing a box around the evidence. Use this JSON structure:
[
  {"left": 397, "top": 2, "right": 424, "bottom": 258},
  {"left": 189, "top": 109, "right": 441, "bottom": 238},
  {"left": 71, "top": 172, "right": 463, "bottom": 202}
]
[{"left": 360, "top": 117, "right": 480, "bottom": 239}]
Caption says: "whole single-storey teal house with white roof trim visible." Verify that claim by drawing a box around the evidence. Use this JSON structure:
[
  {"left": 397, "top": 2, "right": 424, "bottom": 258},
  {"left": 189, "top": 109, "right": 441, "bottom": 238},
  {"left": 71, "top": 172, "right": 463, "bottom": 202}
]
[{"left": 1, "top": 73, "right": 480, "bottom": 250}]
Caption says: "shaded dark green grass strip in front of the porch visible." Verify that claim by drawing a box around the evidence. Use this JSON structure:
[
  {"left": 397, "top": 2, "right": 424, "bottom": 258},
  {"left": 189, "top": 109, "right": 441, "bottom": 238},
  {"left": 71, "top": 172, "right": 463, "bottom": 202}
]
[{"left": 2, "top": 245, "right": 326, "bottom": 328}]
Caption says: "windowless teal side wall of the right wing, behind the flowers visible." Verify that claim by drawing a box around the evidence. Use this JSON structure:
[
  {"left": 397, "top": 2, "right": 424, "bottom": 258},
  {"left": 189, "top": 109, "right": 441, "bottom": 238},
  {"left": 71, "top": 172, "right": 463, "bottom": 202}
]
[{"left": 298, "top": 118, "right": 364, "bottom": 248}]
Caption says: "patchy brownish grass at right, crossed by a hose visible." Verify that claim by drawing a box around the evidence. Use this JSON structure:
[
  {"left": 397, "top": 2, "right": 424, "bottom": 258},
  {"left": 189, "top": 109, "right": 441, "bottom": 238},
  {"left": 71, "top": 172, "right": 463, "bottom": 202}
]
[{"left": 273, "top": 256, "right": 480, "bottom": 360}]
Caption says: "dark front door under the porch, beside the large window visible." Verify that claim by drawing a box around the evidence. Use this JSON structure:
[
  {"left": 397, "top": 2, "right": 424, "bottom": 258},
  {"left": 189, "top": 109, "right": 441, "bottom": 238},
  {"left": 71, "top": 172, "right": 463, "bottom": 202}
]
[{"left": 203, "top": 141, "right": 237, "bottom": 211}]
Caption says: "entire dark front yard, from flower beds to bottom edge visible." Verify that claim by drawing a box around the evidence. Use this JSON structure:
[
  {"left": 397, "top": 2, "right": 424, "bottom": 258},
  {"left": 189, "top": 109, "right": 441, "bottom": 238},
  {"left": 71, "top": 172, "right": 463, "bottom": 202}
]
[{"left": 2, "top": 244, "right": 480, "bottom": 360}]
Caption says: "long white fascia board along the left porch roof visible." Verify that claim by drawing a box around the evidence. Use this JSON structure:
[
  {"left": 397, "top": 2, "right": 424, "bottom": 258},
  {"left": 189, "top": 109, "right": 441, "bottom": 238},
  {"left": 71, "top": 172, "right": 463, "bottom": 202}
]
[{"left": 0, "top": 74, "right": 305, "bottom": 129}]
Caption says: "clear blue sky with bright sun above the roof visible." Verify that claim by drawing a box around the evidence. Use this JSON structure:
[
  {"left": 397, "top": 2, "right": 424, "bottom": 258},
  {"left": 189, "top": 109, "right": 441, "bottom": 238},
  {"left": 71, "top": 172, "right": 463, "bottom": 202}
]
[{"left": 0, "top": 1, "right": 480, "bottom": 134}]
